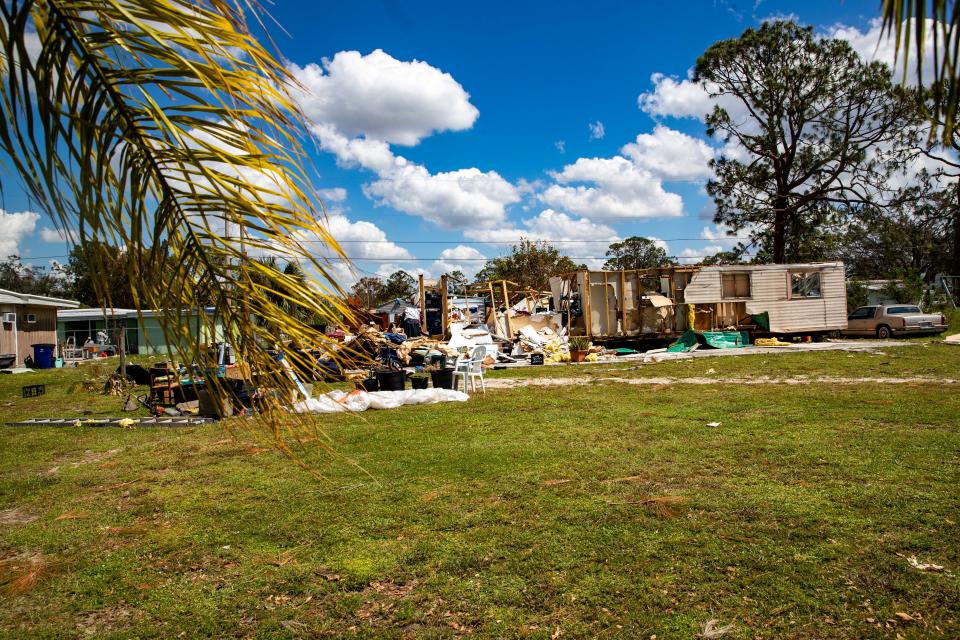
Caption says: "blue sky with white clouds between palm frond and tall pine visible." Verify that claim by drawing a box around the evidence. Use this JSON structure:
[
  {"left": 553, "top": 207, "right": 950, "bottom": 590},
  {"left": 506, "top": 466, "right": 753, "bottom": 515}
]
[{"left": 0, "top": 0, "right": 889, "bottom": 284}]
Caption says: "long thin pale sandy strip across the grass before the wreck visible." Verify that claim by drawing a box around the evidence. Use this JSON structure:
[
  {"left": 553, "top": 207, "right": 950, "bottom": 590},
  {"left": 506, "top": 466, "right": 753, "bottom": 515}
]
[{"left": 486, "top": 376, "right": 958, "bottom": 389}]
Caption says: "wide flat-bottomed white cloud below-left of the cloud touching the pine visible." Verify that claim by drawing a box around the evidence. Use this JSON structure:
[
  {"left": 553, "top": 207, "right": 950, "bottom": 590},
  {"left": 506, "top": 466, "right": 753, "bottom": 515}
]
[{"left": 540, "top": 156, "right": 683, "bottom": 220}]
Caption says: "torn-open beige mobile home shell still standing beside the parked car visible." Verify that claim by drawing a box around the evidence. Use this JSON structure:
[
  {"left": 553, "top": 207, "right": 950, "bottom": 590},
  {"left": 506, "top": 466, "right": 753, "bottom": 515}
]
[{"left": 551, "top": 262, "right": 847, "bottom": 342}]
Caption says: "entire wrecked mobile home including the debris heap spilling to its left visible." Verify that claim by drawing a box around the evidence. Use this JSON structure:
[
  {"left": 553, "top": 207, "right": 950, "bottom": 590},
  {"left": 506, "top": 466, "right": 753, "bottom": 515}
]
[{"left": 328, "top": 262, "right": 847, "bottom": 386}]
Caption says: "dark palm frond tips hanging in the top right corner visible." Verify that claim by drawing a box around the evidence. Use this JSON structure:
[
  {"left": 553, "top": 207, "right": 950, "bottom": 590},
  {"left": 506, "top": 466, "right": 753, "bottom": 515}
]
[{"left": 881, "top": 0, "right": 960, "bottom": 142}]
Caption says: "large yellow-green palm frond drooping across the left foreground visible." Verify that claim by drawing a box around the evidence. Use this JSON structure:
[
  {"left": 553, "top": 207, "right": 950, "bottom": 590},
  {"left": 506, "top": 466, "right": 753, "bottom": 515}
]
[{"left": 0, "top": 0, "right": 358, "bottom": 447}]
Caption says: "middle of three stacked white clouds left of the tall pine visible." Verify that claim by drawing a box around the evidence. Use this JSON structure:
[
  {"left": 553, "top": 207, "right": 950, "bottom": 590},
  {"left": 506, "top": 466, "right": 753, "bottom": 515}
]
[{"left": 620, "top": 124, "right": 715, "bottom": 180}]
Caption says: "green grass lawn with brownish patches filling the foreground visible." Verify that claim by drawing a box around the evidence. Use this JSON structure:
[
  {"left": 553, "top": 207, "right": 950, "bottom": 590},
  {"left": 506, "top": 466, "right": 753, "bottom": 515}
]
[{"left": 0, "top": 344, "right": 960, "bottom": 639}]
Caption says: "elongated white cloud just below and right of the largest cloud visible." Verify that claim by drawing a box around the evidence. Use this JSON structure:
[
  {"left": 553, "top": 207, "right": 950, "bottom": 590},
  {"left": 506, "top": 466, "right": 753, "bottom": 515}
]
[{"left": 363, "top": 158, "right": 520, "bottom": 229}]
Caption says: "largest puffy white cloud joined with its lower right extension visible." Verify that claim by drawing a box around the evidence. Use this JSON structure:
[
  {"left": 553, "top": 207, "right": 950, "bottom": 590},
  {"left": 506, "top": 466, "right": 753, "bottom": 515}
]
[{"left": 291, "top": 50, "right": 521, "bottom": 229}]
